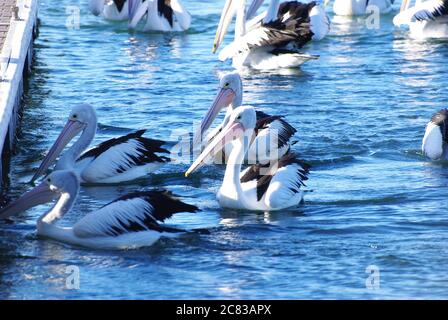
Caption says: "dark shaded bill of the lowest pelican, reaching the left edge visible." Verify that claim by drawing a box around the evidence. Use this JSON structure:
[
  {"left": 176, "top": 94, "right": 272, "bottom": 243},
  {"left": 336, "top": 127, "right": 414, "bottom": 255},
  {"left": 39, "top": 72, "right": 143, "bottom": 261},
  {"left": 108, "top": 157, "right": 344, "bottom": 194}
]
[{"left": 0, "top": 183, "right": 57, "bottom": 219}]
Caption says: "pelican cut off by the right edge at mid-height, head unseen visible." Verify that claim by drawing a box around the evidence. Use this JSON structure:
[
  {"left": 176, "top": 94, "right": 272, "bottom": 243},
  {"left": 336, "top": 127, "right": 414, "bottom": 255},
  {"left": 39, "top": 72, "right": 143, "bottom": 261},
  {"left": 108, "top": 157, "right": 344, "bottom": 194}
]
[{"left": 422, "top": 109, "right": 448, "bottom": 160}]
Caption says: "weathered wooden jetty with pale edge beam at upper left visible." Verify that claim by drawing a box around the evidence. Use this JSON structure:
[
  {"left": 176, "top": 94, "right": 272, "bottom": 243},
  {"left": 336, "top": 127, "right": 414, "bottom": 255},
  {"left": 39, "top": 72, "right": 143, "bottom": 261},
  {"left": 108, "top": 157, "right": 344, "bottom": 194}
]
[{"left": 0, "top": 0, "right": 38, "bottom": 184}]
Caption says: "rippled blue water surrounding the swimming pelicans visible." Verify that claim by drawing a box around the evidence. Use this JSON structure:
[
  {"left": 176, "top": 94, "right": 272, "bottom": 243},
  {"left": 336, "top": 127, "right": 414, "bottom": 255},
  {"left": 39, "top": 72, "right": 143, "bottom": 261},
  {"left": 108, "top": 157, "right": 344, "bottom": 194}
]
[{"left": 0, "top": 0, "right": 448, "bottom": 299}]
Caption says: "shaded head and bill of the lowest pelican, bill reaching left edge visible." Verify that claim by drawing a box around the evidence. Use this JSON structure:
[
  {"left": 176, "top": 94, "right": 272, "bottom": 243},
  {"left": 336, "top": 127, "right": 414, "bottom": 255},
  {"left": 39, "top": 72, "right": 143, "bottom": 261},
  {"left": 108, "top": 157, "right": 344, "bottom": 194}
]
[{"left": 0, "top": 170, "right": 79, "bottom": 219}]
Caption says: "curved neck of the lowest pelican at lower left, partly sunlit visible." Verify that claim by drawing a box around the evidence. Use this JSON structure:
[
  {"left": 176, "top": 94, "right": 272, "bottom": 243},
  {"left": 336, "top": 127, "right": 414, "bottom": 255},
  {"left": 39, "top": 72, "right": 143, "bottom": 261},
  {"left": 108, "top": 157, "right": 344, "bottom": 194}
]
[{"left": 37, "top": 187, "right": 79, "bottom": 234}]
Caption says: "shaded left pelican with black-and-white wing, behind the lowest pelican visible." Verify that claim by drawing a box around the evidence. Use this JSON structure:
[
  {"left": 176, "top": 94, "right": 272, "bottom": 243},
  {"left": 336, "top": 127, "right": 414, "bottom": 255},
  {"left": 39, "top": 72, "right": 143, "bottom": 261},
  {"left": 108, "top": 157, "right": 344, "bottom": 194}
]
[{"left": 31, "top": 104, "right": 169, "bottom": 183}]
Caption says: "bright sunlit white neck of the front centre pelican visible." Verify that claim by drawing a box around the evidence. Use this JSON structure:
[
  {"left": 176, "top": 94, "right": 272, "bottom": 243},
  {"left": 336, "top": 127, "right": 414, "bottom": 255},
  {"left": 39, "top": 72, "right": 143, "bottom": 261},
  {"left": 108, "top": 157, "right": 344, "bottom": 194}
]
[{"left": 222, "top": 130, "right": 253, "bottom": 202}]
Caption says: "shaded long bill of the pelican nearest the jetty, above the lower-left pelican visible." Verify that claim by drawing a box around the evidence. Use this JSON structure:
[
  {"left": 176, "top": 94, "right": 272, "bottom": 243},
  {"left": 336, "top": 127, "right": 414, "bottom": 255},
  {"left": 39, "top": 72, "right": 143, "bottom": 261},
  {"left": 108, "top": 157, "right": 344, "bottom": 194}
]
[{"left": 30, "top": 120, "right": 85, "bottom": 182}]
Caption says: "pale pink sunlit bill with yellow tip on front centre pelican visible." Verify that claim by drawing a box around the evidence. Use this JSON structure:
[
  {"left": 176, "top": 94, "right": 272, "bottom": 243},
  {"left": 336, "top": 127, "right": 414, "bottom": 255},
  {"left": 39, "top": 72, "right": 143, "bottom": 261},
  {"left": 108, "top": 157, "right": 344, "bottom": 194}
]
[{"left": 185, "top": 121, "right": 244, "bottom": 177}]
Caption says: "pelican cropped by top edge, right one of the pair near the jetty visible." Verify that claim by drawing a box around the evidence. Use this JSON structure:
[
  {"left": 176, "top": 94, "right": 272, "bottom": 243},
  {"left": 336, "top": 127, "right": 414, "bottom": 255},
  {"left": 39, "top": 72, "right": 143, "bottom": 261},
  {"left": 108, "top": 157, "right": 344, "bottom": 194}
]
[{"left": 129, "top": 0, "right": 191, "bottom": 32}]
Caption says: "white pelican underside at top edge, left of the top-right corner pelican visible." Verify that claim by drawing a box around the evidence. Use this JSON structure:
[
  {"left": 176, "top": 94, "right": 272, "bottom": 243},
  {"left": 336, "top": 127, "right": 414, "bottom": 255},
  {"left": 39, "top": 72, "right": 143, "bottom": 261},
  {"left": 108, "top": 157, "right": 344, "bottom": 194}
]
[{"left": 324, "top": 0, "right": 395, "bottom": 16}]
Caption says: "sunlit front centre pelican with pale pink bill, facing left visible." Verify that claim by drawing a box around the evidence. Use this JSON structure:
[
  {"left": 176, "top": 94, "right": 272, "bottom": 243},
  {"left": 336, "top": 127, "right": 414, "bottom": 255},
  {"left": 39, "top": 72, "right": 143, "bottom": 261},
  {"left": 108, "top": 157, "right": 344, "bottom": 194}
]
[{"left": 185, "top": 107, "right": 309, "bottom": 211}]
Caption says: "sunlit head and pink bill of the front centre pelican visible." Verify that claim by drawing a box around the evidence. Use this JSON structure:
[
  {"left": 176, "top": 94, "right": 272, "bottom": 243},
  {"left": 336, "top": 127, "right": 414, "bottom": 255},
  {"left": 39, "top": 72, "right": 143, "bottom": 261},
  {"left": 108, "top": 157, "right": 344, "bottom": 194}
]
[{"left": 185, "top": 106, "right": 257, "bottom": 177}]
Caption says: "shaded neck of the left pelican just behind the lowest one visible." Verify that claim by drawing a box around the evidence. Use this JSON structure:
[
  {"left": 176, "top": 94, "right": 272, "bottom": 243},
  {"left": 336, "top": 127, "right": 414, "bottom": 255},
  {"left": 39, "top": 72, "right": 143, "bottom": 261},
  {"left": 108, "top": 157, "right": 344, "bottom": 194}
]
[{"left": 55, "top": 120, "right": 97, "bottom": 170}]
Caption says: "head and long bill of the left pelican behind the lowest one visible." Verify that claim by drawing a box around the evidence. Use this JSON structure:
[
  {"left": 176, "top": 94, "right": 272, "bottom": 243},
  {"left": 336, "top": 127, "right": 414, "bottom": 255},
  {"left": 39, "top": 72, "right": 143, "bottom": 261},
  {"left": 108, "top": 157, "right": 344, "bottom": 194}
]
[{"left": 31, "top": 104, "right": 97, "bottom": 182}]
